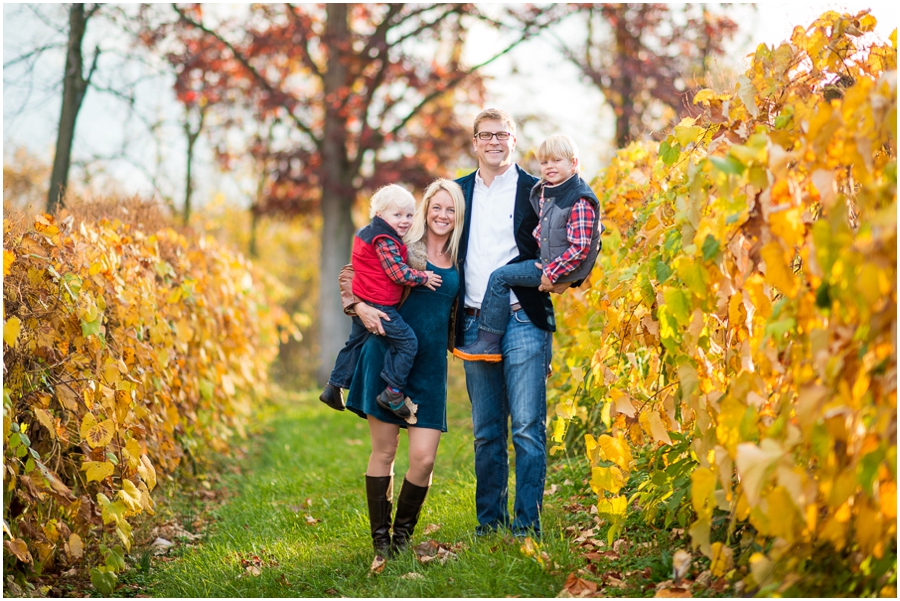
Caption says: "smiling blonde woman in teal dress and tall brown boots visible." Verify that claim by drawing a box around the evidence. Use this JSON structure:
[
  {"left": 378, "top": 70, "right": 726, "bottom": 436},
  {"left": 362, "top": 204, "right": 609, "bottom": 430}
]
[{"left": 341, "top": 179, "right": 465, "bottom": 557}]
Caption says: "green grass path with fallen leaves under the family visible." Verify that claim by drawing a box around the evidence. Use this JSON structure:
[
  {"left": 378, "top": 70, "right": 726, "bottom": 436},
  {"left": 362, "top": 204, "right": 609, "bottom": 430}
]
[{"left": 142, "top": 361, "right": 584, "bottom": 597}]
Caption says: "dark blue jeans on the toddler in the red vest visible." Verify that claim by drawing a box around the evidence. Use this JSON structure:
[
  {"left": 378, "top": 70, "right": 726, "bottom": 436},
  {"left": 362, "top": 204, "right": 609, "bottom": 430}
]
[{"left": 328, "top": 303, "right": 419, "bottom": 390}]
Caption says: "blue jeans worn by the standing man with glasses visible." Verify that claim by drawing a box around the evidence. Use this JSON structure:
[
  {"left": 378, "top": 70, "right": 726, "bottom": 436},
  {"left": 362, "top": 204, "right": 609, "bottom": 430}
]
[{"left": 463, "top": 311, "right": 553, "bottom": 535}]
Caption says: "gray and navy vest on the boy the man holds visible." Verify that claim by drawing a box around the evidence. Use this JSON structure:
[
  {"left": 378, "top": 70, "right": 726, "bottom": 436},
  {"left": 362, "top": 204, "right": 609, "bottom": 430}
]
[{"left": 530, "top": 173, "right": 602, "bottom": 286}]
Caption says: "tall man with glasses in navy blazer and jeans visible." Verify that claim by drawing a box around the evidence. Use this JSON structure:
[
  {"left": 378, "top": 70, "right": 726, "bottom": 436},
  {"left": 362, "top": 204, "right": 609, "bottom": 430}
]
[{"left": 455, "top": 109, "right": 569, "bottom": 537}]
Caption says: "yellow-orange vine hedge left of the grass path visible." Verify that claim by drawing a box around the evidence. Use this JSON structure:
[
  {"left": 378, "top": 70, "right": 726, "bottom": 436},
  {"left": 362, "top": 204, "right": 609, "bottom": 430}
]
[{"left": 3, "top": 206, "right": 288, "bottom": 594}]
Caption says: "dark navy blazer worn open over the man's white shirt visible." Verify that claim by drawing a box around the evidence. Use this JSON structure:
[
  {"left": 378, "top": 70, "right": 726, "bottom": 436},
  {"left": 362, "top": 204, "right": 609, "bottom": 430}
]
[{"left": 456, "top": 165, "right": 556, "bottom": 346}]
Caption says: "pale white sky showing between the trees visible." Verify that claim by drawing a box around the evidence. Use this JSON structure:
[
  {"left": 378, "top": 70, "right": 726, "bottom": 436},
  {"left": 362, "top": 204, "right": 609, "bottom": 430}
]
[{"left": 2, "top": 1, "right": 898, "bottom": 213}]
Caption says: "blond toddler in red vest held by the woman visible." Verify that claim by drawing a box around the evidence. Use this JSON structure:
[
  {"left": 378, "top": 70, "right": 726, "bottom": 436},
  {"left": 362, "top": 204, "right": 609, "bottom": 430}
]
[{"left": 319, "top": 184, "right": 441, "bottom": 419}]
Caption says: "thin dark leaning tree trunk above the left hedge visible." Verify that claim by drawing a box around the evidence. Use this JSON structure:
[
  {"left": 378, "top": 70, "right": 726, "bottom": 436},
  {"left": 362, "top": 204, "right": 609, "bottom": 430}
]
[{"left": 47, "top": 4, "right": 97, "bottom": 213}]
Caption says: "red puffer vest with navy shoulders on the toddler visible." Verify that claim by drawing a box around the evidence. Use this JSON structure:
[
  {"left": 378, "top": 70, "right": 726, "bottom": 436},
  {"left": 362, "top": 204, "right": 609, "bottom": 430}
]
[{"left": 350, "top": 217, "right": 407, "bottom": 305}]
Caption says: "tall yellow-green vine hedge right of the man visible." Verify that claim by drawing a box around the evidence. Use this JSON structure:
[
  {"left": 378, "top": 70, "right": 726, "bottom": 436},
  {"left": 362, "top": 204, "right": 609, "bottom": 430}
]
[{"left": 551, "top": 12, "right": 897, "bottom": 596}]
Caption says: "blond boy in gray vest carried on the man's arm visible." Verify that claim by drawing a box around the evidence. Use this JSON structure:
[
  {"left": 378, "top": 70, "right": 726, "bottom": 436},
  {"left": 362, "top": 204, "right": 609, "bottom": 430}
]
[{"left": 453, "top": 135, "right": 602, "bottom": 363}]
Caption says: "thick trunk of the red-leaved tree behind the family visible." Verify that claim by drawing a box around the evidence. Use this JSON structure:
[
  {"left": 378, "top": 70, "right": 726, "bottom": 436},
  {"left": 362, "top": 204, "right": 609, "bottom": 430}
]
[{"left": 317, "top": 4, "right": 355, "bottom": 385}]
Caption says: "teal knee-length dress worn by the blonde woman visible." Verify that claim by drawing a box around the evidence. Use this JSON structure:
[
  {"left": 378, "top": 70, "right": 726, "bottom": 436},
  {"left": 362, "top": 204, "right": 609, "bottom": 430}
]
[{"left": 346, "top": 263, "right": 459, "bottom": 432}]
